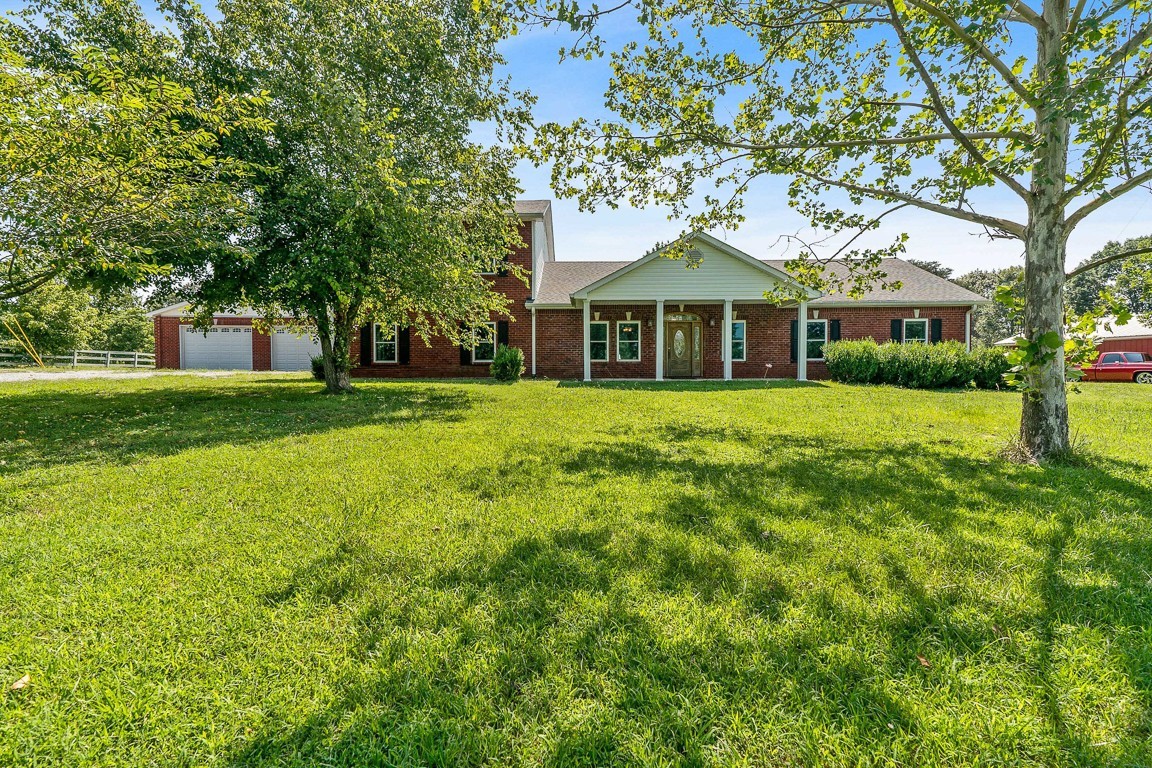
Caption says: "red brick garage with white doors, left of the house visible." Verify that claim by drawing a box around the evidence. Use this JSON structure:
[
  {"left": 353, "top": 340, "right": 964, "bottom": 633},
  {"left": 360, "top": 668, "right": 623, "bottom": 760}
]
[{"left": 151, "top": 302, "right": 320, "bottom": 371}]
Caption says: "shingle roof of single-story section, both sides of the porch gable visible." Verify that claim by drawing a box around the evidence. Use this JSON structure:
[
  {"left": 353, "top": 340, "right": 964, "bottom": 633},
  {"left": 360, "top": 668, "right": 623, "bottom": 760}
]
[{"left": 534, "top": 257, "right": 987, "bottom": 305}]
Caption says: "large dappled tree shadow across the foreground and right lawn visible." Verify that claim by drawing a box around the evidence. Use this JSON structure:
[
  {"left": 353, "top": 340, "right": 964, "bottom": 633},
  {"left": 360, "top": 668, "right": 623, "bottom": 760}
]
[{"left": 226, "top": 435, "right": 1152, "bottom": 766}]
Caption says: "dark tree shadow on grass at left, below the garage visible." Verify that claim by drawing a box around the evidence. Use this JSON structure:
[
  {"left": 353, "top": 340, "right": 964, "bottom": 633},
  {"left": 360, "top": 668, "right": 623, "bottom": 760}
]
[{"left": 0, "top": 378, "right": 475, "bottom": 478}]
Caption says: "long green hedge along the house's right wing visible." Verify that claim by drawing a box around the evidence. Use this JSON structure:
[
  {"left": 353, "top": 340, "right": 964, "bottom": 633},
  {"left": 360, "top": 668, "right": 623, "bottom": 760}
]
[{"left": 824, "top": 339, "right": 1008, "bottom": 389}]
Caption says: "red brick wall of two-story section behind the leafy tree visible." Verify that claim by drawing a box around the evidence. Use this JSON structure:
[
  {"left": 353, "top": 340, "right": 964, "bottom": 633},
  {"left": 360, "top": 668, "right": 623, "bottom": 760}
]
[{"left": 351, "top": 221, "right": 534, "bottom": 379}]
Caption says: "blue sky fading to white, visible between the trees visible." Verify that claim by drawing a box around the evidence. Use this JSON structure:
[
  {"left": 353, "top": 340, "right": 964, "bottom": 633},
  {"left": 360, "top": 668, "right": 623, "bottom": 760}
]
[{"left": 11, "top": 0, "right": 1152, "bottom": 273}]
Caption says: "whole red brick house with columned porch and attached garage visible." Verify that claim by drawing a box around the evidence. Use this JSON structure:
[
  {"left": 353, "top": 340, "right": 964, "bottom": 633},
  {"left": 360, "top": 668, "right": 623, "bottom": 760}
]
[{"left": 153, "top": 200, "right": 987, "bottom": 381}]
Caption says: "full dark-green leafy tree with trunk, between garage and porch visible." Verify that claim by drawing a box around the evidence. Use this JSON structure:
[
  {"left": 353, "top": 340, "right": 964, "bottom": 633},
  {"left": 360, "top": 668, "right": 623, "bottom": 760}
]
[{"left": 184, "top": 0, "right": 528, "bottom": 391}]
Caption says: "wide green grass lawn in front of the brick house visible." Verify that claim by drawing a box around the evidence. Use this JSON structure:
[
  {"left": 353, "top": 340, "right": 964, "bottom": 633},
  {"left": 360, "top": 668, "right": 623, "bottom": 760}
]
[{"left": 0, "top": 375, "right": 1152, "bottom": 766}]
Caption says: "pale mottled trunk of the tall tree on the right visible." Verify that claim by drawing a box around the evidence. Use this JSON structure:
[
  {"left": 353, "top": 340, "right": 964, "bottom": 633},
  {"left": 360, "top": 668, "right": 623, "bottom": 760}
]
[{"left": 1020, "top": 0, "right": 1069, "bottom": 461}]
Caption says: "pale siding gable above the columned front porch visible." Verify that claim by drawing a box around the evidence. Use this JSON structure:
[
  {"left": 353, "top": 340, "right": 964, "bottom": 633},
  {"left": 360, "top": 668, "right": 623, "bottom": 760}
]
[{"left": 588, "top": 241, "right": 779, "bottom": 302}]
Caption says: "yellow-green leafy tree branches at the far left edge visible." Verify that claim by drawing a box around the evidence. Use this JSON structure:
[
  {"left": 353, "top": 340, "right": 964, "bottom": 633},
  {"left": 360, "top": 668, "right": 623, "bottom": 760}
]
[{"left": 0, "top": 22, "right": 266, "bottom": 299}]
